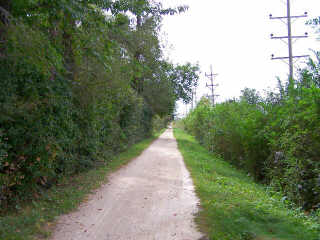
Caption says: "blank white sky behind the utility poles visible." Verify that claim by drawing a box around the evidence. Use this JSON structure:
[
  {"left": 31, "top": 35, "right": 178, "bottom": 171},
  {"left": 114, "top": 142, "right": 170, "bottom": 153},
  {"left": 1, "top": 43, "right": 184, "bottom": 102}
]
[{"left": 162, "top": 0, "right": 320, "bottom": 114}]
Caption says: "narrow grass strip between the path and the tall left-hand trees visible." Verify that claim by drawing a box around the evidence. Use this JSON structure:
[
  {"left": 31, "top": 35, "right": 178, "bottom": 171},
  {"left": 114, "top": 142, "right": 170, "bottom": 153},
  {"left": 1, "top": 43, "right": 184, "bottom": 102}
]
[{"left": 0, "top": 131, "right": 163, "bottom": 240}]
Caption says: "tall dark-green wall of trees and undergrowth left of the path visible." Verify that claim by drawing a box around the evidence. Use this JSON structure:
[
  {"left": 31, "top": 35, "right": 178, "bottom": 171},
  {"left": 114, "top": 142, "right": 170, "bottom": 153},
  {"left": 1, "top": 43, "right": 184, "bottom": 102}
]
[{"left": 0, "top": 0, "right": 199, "bottom": 209}]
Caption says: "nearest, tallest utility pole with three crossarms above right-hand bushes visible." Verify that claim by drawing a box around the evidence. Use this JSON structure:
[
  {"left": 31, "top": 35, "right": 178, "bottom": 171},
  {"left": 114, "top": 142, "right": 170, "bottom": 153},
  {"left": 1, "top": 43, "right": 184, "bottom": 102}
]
[{"left": 269, "top": 0, "right": 309, "bottom": 81}]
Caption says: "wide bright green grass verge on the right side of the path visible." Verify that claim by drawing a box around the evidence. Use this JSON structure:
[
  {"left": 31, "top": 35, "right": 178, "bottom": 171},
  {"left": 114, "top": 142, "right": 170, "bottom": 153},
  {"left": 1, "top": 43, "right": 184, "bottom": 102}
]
[{"left": 174, "top": 128, "right": 320, "bottom": 240}]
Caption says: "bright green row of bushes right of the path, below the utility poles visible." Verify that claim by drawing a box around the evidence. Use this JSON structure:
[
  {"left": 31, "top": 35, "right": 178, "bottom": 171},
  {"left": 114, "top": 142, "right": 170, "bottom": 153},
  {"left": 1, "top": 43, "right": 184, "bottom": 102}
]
[{"left": 183, "top": 61, "right": 320, "bottom": 209}]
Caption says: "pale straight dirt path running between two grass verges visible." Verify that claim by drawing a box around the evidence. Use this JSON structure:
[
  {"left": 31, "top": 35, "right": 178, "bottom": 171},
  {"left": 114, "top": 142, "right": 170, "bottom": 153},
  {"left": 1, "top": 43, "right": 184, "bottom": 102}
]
[{"left": 52, "top": 129, "right": 202, "bottom": 240}]
